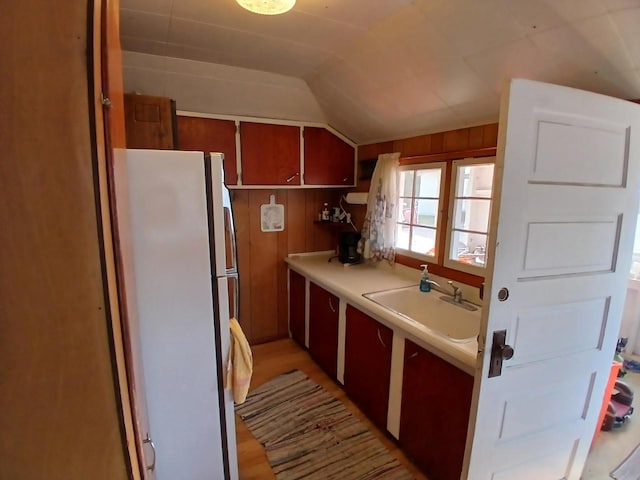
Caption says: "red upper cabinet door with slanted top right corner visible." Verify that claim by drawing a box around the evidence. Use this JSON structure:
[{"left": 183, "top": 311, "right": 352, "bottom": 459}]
[{"left": 304, "top": 127, "right": 355, "bottom": 186}]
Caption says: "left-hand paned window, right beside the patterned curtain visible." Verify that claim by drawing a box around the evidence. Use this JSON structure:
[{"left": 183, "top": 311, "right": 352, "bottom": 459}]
[{"left": 395, "top": 163, "right": 446, "bottom": 261}]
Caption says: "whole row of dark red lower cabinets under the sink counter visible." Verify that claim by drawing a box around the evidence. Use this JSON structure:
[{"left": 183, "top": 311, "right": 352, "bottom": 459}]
[{"left": 289, "top": 270, "right": 473, "bottom": 480}]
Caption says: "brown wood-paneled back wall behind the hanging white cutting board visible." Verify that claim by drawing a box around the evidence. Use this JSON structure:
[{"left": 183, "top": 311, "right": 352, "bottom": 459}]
[{"left": 231, "top": 188, "right": 345, "bottom": 344}]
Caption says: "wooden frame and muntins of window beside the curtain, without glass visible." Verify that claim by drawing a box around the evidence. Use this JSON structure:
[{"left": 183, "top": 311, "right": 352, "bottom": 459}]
[{"left": 394, "top": 162, "right": 448, "bottom": 263}]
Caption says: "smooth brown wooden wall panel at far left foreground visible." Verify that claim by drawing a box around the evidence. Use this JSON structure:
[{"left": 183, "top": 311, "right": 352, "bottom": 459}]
[{"left": 0, "top": 0, "right": 128, "bottom": 480}]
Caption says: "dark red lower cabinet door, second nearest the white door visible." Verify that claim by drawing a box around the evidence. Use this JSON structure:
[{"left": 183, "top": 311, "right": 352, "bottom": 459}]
[{"left": 344, "top": 305, "right": 393, "bottom": 430}]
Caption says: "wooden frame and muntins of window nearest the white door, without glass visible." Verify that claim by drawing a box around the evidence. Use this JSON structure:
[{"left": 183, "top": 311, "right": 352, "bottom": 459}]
[{"left": 442, "top": 156, "right": 496, "bottom": 276}]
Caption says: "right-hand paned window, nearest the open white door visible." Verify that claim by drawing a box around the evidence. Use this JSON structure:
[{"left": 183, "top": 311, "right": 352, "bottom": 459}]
[{"left": 444, "top": 157, "right": 494, "bottom": 275}]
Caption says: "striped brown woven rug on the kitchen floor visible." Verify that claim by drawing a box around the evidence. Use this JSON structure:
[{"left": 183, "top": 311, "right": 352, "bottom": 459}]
[{"left": 236, "top": 370, "right": 413, "bottom": 480}]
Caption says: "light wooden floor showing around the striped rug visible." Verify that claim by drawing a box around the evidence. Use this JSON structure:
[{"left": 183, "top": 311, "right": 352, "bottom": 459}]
[{"left": 236, "top": 339, "right": 427, "bottom": 480}]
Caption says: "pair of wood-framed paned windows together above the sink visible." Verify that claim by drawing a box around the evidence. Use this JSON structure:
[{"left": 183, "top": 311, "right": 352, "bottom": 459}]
[{"left": 395, "top": 157, "right": 495, "bottom": 278}]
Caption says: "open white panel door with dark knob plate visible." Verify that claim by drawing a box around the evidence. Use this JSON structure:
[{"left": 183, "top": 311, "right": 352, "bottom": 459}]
[{"left": 463, "top": 80, "right": 640, "bottom": 480}]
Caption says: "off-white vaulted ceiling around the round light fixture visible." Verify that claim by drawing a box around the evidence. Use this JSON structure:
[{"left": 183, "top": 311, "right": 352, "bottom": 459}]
[{"left": 121, "top": 0, "right": 640, "bottom": 144}]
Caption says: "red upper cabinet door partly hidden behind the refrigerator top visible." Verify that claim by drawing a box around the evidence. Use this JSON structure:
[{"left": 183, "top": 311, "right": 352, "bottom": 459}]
[{"left": 177, "top": 115, "right": 238, "bottom": 185}]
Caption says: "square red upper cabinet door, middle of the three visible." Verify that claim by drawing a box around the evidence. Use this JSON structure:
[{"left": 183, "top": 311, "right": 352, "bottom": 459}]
[{"left": 240, "top": 122, "right": 300, "bottom": 185}]
